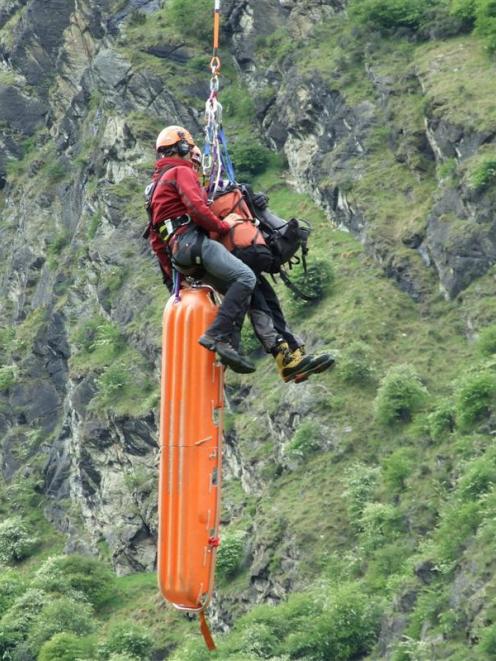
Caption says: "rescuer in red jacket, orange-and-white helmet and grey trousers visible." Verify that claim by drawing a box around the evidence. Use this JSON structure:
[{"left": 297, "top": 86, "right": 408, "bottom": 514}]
[{"left": 148, "top": 126, "right": 256, "bottom": 373}]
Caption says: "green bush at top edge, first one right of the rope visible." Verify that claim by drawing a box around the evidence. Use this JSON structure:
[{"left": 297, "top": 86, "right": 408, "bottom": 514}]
[{"left": 349, "top": 0, "right": 429, "bottom": 31}]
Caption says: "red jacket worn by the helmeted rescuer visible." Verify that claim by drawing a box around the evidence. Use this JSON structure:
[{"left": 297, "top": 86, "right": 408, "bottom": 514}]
[{"left": 150, "top": 156, "right": 230, "bottom": 276}]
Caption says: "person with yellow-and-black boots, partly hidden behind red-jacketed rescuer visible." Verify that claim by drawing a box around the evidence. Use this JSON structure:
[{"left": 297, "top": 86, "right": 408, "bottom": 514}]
[{"left": 191, "top": 146, "right": 334, "bottom": 382}]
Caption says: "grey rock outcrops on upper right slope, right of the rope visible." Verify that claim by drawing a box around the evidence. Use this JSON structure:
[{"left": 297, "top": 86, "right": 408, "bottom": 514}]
[{"left": 228, "top": 1, "right": 496, "bottom": 300}]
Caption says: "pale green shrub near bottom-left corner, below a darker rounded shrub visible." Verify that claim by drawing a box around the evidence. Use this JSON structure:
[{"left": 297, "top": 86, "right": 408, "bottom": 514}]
[{"left": 27, "top": 597, "right": 96, "bottom": 657}]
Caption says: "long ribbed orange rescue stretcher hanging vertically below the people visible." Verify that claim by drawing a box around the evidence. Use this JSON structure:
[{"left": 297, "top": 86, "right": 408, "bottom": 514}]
[{"left": 158, "top": 286, "right": 224, "bottom": 644}]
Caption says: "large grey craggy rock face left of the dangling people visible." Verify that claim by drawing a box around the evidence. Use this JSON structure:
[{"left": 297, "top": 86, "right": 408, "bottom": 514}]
[{"left": 0, "top": 0, "right": 200, "bottom": 573}]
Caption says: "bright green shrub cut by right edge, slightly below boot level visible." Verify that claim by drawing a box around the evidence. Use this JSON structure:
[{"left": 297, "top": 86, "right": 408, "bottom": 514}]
[{"left": 456, "top": 371, "right": 496, "bottom": 429}]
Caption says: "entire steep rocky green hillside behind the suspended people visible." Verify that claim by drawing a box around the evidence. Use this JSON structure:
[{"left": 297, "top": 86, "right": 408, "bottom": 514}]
[{"left": 0, "top": 0, "right": 496, "bottom": 661}]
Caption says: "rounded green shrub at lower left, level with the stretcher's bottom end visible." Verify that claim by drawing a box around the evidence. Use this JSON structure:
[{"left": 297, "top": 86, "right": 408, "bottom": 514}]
[{"left": 32, "top": 555, "right": 115, "bottom": 608}]
